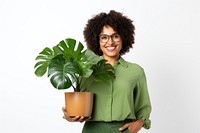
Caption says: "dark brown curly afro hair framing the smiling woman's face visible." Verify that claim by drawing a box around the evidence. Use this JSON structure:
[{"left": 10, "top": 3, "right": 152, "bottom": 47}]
[{"left": 83, "top": 10, "right": 135, "bottom": 56}]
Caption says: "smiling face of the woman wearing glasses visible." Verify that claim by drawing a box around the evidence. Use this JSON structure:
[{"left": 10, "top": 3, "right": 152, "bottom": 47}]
[{"left": 99, "top": 26, "right": 122, "bottom": 59}]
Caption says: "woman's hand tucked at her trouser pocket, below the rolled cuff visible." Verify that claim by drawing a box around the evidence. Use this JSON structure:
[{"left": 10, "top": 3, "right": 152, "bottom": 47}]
[{"left": 119, "top": 119, "right": 144, "bottom": 133}]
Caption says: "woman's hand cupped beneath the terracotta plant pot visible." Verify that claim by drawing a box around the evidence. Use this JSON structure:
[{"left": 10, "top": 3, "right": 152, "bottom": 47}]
[{"left": 62, "top": 107, "right": 91, "bottom": 122}]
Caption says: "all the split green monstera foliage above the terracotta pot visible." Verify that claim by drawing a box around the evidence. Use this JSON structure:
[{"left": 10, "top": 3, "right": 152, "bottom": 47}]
[{"left": 34, "top": 38, "right": 114, "bottom": 91}]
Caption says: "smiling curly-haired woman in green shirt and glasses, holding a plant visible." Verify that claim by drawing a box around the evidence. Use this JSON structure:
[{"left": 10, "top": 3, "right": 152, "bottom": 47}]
[{"left": 63, "top": 10, "right": 151, "bottom": 133}]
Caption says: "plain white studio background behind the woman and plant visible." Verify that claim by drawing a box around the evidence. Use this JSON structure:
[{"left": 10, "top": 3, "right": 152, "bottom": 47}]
[{"left": 0, "top": 0, "right": 200, "bottom": 133}]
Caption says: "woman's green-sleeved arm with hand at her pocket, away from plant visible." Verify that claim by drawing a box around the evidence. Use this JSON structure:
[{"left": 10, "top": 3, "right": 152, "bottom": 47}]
[{"left": 119, "top": 71, "right": 151, "bottom": 133}]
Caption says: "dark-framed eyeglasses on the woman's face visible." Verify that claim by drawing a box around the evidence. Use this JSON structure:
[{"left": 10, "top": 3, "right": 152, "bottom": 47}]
[{"left": 99, "top": 33, "right": 120, "bottom": 43}]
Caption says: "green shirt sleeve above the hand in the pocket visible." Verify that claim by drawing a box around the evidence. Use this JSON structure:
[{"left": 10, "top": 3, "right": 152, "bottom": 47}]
[{"left": 134, "top": 70, "right": 152, "bottom": 129}]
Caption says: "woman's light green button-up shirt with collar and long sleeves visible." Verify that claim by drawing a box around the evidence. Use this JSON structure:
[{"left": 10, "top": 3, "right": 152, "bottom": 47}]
[{"left": 80, "top": 58, "right": 151, "bottom": 129}]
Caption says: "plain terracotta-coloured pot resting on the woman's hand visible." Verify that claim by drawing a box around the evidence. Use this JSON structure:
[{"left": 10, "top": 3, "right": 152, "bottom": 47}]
[{"left": 65, "top": 92, "right": 94, "bottom": 117}]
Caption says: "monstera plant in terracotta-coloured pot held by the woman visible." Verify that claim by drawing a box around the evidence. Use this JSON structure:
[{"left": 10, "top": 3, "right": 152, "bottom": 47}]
[{"left": 34, "top": 38, "right": 114, "bottom": 117}]
